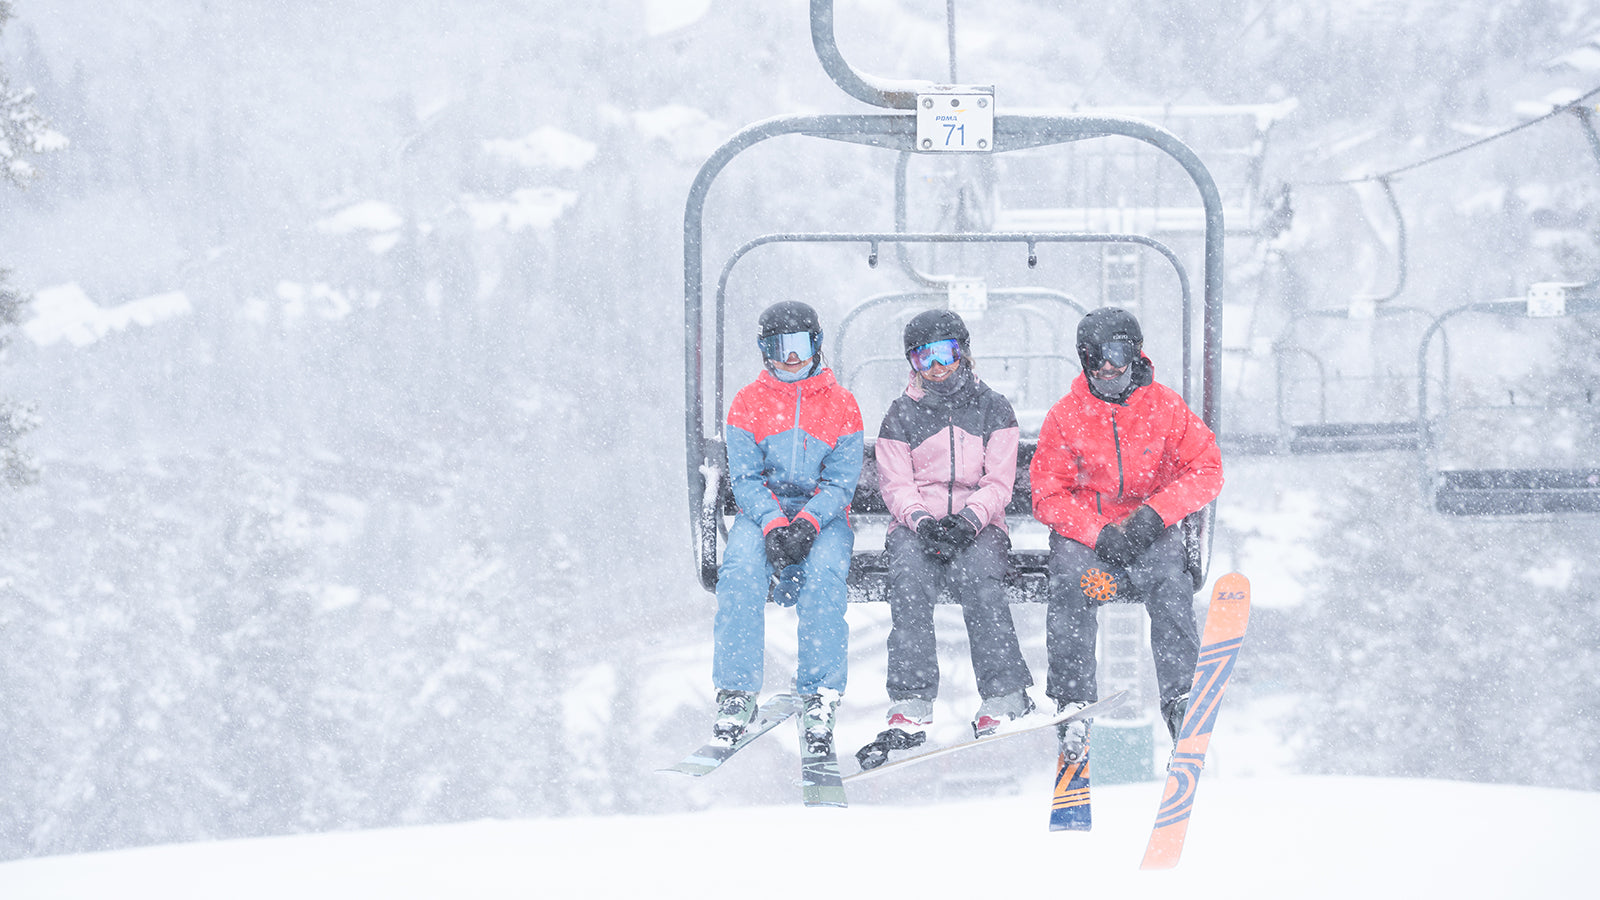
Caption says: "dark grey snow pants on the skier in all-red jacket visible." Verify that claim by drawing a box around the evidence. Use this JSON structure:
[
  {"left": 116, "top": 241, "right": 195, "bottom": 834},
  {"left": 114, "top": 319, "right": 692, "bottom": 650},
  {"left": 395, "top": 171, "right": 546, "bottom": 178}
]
[{"left": 1045, "top": 527, "right": 1200, "bottom": 703}]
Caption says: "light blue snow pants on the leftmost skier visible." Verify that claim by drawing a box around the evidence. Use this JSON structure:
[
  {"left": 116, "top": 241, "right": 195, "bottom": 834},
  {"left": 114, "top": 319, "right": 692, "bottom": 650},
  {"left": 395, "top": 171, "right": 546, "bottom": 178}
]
[{"left": 710, "top": 516, "right": 856, "bottom": 693}]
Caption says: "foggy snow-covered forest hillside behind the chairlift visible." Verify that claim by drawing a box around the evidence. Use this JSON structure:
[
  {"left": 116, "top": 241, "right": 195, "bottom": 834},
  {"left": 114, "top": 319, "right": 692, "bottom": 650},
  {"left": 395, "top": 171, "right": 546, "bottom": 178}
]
[{"left": 0, "top": 0, "right": 1600, "bottom": 858}]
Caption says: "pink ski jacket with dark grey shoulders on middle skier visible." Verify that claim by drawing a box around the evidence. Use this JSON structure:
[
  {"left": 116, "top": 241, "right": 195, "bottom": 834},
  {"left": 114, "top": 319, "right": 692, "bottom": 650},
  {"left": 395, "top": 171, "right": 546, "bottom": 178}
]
[{"left": 874, "top": 370, "right": 1019, "bottom": 530}]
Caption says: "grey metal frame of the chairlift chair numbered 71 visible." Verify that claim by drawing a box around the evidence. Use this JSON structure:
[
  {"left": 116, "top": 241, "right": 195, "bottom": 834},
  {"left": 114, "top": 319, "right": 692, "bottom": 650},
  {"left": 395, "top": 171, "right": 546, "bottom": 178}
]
[{"left": 683, "top": 0, "right": 1224, "bottom": 601}]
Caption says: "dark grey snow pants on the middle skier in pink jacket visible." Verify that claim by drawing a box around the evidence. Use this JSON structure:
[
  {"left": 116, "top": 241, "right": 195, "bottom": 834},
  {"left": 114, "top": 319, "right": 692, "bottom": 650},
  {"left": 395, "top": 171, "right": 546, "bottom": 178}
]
[{"left": 885, "top": 525, "right": 1034, "bottom": 701}]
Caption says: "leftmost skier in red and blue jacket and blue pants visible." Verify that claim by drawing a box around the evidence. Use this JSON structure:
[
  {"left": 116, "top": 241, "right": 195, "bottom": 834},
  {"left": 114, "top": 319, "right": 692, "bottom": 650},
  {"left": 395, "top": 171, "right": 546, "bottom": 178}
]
[{"left": 712, "top": 301, "right": 864, "bottom": 751}]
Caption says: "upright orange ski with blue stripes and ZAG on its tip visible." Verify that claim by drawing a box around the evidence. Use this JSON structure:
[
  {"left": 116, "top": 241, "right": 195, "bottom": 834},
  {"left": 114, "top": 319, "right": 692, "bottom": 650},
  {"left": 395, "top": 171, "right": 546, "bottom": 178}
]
[{"left": 1139, "top": 572, "right": 1250, "bottom": 870}]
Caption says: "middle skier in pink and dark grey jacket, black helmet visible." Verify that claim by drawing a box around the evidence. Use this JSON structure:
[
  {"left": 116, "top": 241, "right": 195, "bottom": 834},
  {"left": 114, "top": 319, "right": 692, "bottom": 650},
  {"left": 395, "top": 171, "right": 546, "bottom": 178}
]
[{"left": 856, "top": 309, "right": 1034, "bottom": 769}]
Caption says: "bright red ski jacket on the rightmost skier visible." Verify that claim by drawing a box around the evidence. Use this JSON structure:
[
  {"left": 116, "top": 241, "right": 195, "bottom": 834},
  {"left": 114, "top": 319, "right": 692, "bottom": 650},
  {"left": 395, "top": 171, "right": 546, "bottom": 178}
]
[{"left": 1029, "top": 365, "right": 1222, "bottom": 548}]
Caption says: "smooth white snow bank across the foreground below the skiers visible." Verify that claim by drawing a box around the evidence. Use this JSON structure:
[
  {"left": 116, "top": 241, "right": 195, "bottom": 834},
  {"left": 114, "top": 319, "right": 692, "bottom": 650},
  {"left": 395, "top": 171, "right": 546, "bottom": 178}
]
[{"left": 0, "top": 762, "right": 1580, "bottom": 900}]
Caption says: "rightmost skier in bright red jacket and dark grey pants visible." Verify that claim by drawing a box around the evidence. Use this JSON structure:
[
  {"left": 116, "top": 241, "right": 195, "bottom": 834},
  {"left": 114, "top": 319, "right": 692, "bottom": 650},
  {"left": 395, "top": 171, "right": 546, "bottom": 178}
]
[{"left": 1029, "top": 307, "right": 1222, "bottom": 759}]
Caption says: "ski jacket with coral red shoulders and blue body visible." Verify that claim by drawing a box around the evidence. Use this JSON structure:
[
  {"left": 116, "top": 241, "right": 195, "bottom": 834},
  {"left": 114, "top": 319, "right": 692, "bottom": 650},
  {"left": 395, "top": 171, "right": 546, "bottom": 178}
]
[{"left": 726, "top": 368, "right": 864, "bottom": 535}]
